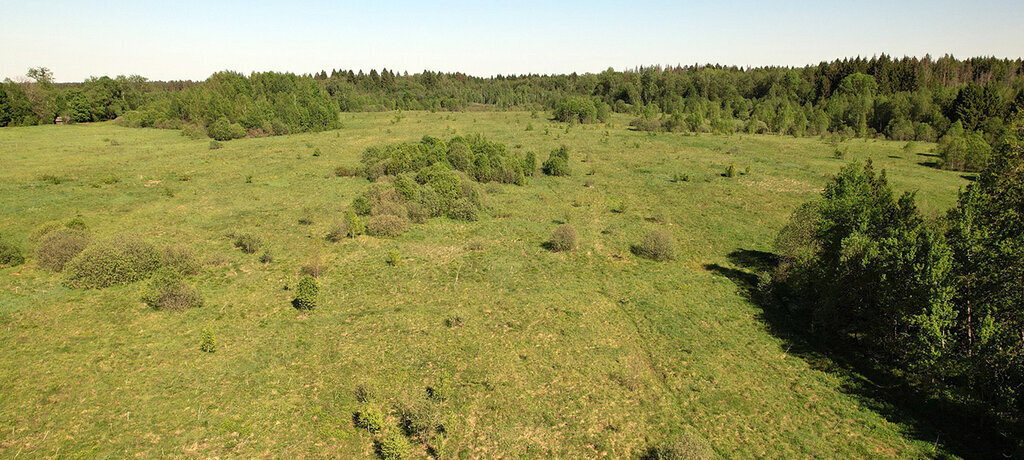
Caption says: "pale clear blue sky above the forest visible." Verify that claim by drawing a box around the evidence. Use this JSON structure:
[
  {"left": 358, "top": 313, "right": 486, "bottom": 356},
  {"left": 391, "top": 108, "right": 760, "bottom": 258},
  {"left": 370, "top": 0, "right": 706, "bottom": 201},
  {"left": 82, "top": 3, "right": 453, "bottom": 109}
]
[{"left": 0, "top": 0, "right": 1024, "bottom": 81}]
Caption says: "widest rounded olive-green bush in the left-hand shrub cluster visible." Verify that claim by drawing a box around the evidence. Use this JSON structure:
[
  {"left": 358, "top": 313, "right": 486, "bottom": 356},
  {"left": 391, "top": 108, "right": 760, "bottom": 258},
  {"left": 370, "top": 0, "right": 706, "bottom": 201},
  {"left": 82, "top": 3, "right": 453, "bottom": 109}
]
[{"left": 65, "top": 237, "right": 161, "bottom": 289}]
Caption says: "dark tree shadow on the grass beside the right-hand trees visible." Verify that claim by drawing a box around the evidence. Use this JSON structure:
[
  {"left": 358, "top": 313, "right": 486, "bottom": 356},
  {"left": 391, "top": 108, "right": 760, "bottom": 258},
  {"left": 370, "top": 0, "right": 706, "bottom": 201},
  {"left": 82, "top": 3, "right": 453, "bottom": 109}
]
[{"left": 705, "top": 249, "right": 1019, "bottom": 458}]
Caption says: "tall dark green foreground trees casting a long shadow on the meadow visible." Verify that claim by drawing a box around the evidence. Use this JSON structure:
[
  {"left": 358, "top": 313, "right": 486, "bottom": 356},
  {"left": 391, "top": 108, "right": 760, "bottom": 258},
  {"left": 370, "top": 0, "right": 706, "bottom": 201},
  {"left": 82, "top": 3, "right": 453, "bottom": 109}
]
[{"left": 762, "top": 118, "right": 1024, "bottom": 448}]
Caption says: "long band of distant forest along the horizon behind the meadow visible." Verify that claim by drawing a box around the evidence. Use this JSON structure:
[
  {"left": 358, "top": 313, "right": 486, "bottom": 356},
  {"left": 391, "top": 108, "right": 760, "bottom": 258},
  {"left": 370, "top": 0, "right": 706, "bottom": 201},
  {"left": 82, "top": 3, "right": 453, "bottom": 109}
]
[{"left": 6, "top": 54, "right": 1024, "bottom": 171}]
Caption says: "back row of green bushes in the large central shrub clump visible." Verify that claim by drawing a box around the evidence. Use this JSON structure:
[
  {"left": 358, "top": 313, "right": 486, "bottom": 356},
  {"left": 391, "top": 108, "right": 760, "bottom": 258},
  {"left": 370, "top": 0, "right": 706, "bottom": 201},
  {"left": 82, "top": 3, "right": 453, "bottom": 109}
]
[{"left": 361, "top": 135, "right": 536, "bottom": 185}]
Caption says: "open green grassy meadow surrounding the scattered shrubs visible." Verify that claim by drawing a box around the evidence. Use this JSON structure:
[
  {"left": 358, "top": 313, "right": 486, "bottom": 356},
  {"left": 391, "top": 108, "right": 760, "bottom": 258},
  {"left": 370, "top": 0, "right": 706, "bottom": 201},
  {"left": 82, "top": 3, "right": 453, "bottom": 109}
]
[{"left": 0, "top": 112, "right": 967, "bottom": 458}]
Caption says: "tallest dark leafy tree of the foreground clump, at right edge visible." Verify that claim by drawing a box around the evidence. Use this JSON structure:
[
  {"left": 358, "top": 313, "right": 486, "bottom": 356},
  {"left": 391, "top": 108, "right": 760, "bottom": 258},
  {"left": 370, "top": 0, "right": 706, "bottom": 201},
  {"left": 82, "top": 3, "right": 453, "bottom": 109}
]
[{"left": 946, "top": 121, "right": 1024, "bottom": 420}]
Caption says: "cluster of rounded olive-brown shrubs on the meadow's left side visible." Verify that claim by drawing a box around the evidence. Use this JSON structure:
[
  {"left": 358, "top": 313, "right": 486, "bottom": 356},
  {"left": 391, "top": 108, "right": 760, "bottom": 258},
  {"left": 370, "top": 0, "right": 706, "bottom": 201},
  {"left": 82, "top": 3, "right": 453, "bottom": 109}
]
[{"left": 32, "top": 218, "right": 203, "bottom": 309}]
